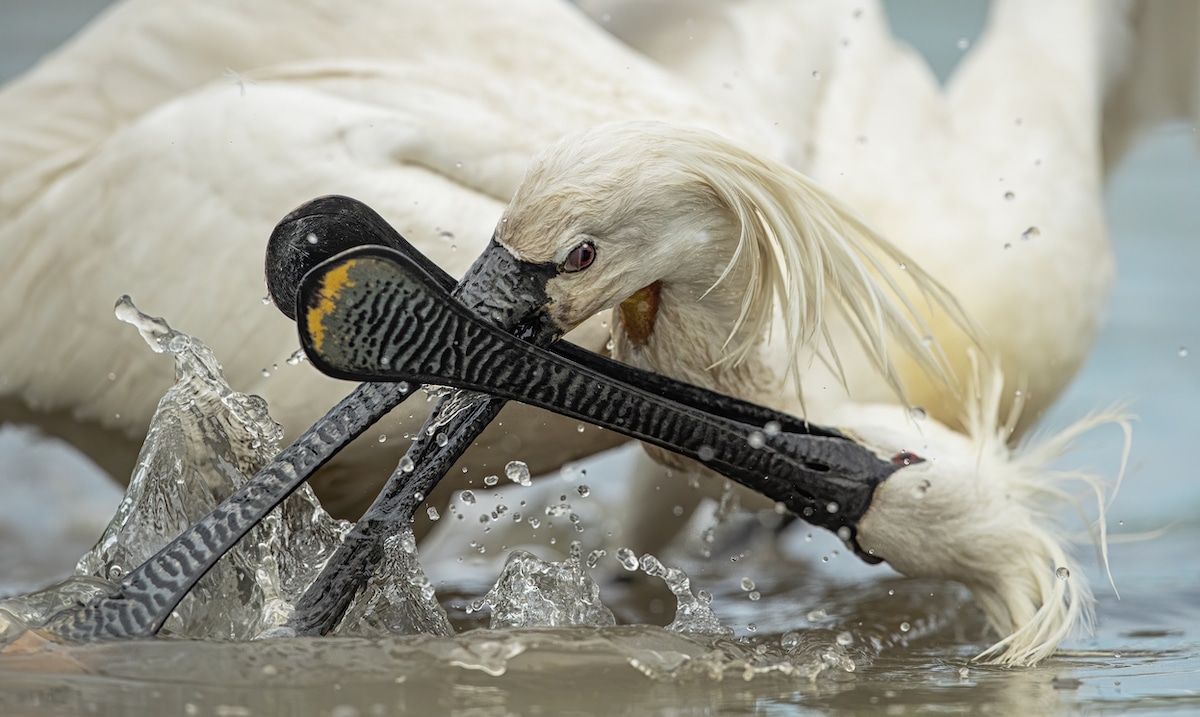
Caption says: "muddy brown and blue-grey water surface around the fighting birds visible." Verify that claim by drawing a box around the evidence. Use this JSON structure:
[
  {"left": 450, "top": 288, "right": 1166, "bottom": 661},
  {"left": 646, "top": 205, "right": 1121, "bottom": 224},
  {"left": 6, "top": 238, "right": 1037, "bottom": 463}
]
[{"left": 0, "top": 0, "right": 1200, "bottom": 717}]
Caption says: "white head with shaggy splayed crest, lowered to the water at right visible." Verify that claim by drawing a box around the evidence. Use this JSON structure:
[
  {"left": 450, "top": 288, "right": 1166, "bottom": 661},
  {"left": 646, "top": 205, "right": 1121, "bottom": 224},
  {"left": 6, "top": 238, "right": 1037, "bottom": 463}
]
[{"left": 822, "top": 359, "right": 1129, "bottom": 664}]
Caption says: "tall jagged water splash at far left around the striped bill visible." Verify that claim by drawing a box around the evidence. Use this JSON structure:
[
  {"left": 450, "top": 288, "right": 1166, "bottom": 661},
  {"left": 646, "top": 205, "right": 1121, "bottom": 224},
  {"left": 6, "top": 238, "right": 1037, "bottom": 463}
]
[{"left": 5, "top": 296, "right": 349, "bottom": 639}]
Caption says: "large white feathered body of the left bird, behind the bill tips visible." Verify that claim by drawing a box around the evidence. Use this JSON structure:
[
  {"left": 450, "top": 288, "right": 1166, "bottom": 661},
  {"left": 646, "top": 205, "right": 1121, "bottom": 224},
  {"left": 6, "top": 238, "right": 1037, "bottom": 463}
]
[{"left": 0, "top": 0, "right": 786, "bottom": 514}]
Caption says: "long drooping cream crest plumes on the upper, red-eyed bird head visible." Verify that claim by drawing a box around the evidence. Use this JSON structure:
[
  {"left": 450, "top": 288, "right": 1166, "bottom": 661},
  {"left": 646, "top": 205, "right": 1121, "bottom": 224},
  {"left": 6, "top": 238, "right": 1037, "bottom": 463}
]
[{"left": 677, "top": 128, "right": 976, "bottom": 398}]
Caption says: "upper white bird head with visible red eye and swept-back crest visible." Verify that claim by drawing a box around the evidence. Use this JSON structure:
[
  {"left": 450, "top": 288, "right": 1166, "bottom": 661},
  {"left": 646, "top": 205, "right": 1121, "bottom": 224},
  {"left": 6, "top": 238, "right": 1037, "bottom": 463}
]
[{"left": 496, "top": 121, "right": 967, "bottom": 392}]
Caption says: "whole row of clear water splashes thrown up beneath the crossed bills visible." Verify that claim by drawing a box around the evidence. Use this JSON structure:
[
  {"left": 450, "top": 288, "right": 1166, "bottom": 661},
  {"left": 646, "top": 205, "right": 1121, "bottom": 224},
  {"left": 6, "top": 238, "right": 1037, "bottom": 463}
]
[{"left": 0, "top": 299, "right": 936, "bottom": 680}]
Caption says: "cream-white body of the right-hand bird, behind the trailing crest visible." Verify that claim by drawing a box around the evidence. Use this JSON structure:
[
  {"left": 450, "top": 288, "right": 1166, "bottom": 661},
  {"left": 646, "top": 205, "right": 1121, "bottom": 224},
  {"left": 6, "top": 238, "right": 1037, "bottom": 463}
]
[{"left": 582, "top": 0, "right": 1200, "bottom": 436}]
